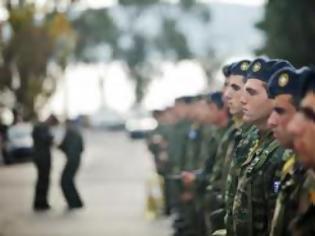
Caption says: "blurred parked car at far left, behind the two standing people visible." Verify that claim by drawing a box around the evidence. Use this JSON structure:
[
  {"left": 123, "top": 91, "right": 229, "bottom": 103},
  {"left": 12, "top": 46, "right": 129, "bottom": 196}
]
[{"left": 4, "top": 122, "right": 33, "bottom": 163}]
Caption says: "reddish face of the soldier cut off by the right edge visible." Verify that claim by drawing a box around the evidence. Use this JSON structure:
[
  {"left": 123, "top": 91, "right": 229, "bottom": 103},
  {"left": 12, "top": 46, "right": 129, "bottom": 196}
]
[{"left": 288, "top": 93, "right": 315, "bottom": 167}]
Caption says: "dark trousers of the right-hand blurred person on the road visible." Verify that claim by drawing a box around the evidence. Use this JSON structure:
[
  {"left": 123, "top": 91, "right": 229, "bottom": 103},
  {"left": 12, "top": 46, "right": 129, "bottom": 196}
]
[{"left": 61, "top": 156, "right": 83, "bottom": 208}]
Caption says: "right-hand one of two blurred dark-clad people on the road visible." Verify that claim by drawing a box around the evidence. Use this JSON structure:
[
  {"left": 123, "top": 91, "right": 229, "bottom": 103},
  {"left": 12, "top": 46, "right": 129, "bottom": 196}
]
[{"left": 59, "top": 120, "right": 84, "bottom": 210}]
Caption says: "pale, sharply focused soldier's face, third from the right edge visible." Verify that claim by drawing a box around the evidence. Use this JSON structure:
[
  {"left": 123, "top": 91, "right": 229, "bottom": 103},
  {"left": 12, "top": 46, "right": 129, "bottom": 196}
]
[{"left": 241, "top": 79, "right": 272, "bottom": 125}]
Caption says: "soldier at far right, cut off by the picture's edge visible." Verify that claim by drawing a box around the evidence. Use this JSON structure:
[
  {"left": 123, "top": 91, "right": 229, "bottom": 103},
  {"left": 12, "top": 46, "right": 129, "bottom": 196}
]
[{"left": 288, "top": 71, "right": 315, "bottom": 236}]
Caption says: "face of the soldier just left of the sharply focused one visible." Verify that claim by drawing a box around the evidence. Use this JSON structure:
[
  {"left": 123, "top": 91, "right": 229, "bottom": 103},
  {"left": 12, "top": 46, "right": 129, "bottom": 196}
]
[{"left": 224, "top": 75, "right": 244, "bottom": 115}]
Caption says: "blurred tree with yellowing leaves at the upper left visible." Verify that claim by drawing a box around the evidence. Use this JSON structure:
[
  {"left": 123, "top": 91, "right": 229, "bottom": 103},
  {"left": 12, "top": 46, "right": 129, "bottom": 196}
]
[{"left": 0, "top": 1, "right": 75, "bottom": 118}]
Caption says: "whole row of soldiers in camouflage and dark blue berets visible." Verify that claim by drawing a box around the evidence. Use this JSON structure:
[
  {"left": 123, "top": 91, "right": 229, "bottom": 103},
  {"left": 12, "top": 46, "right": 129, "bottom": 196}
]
[{"left": 147, "top": 57, "right": 315, "bottom": 236}]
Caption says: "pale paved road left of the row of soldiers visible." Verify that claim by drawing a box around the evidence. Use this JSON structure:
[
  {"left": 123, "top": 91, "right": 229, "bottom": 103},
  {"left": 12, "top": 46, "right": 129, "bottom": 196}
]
[{"left": 0, "top": 131, "right": 171, "bottom": 236}]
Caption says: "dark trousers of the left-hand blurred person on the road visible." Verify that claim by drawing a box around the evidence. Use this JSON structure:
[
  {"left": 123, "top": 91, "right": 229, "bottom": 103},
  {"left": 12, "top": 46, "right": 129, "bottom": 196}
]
[{"left": 33, "top": 155, "right": 51, "bottom": 208}]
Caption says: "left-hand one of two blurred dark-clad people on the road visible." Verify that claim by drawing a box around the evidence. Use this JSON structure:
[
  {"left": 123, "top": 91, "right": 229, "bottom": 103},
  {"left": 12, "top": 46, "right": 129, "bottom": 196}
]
[{"left": 32, "top": 115, "right": 58, "bottom": 211}]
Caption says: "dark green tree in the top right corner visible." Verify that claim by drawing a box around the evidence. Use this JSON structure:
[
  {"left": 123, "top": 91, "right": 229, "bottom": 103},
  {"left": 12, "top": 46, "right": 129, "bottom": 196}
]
[{"left": 257, "top": 0, "right": 315, "bottom": 67}]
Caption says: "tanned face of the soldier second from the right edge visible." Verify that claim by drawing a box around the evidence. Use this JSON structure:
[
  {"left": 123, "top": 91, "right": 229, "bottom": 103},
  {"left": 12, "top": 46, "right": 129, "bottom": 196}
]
[{"left": 268, "top": 95, "right": 296, "bottom": 148}]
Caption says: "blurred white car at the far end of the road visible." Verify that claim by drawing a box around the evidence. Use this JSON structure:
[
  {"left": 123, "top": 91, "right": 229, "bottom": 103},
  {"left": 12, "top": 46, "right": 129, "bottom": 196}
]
[{"left": 125, "top": 110, "right": 157, "bottom": 139}]
